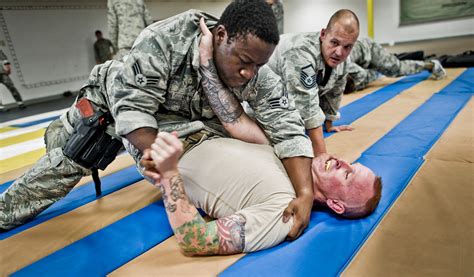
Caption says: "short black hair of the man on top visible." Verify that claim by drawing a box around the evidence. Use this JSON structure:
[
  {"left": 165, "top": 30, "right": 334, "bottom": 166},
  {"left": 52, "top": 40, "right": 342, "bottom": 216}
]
[{"left": 217, "top": 0, "right": 280, "bottom": 45}]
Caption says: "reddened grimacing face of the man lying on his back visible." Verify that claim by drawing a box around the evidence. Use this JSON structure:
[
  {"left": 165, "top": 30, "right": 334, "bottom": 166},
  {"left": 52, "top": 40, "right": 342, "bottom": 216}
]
[{"left": 312, "top": 154, "right": 375, "bottom": 207}]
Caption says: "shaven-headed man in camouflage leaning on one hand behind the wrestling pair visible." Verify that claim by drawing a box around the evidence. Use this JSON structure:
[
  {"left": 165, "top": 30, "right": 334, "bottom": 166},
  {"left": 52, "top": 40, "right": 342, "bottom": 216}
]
[{"left": 268, "top": 10, "right": 359, "bottom": 155}]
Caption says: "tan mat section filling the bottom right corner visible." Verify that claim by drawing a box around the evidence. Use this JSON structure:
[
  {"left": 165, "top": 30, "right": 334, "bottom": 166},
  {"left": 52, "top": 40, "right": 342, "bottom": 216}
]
[{"left": 343, "top": 98, "right": 474, "bottom": 277}]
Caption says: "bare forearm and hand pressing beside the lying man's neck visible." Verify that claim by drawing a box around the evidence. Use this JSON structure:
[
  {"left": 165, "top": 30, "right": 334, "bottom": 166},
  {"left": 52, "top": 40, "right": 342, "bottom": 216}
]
[{"left": 282, "top": 157, "right": 313, "bottom": 240}]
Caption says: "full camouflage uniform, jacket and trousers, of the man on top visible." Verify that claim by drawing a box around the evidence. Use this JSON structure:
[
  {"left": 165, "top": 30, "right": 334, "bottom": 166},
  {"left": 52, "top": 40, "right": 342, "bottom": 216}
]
[{"left": 0, "top": 11, "right": 312, "bottom": 230}]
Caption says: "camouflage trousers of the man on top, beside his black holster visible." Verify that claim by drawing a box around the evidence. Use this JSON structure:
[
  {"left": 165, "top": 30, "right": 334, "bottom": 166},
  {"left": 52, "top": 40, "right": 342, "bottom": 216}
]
[{"left": 0, "top": 61, "right": 121, "bottom": 230}]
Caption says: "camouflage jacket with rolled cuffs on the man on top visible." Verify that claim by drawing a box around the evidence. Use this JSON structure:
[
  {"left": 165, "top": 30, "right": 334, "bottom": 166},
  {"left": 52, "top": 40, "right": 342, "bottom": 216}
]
[{"left": 112, "top": 10, "right": 312, "bottom": 158}]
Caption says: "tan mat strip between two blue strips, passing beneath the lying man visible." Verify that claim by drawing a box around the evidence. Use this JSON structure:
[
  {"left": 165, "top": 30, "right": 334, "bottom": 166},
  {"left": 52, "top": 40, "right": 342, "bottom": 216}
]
[{"left": 112, "top": 69, "right": 465, "bottom": 276}]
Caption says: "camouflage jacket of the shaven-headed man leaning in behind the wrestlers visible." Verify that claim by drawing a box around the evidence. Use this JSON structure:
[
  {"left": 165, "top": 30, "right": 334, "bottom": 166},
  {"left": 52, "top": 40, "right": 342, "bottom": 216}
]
[{"left": 268, "top": 32, "right": 347, "bottom": 129}]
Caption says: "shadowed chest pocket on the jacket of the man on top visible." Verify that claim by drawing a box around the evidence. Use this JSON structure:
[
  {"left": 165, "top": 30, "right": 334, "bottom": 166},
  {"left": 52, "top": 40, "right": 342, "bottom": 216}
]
[{"left": 166, "top": 59, "right": 198, "bottom": 117}]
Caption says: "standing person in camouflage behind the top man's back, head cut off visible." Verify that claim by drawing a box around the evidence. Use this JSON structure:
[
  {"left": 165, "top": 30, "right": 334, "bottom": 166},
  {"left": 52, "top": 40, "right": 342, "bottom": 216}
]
[{"left": 107, "top": 0, "right": 153, "bottom": 60}]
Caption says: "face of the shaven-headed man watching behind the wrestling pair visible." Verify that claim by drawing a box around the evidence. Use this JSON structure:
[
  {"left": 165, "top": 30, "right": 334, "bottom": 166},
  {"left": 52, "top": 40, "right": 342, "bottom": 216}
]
[{"left": 320, "top": 22, "right": 359, "bottom": 68}]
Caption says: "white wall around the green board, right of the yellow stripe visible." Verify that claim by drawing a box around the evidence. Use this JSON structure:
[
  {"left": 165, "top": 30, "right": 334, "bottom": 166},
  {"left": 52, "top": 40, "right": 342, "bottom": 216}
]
[{"left": 374, "top": 0, "right": 474, "bottom": 43}]
